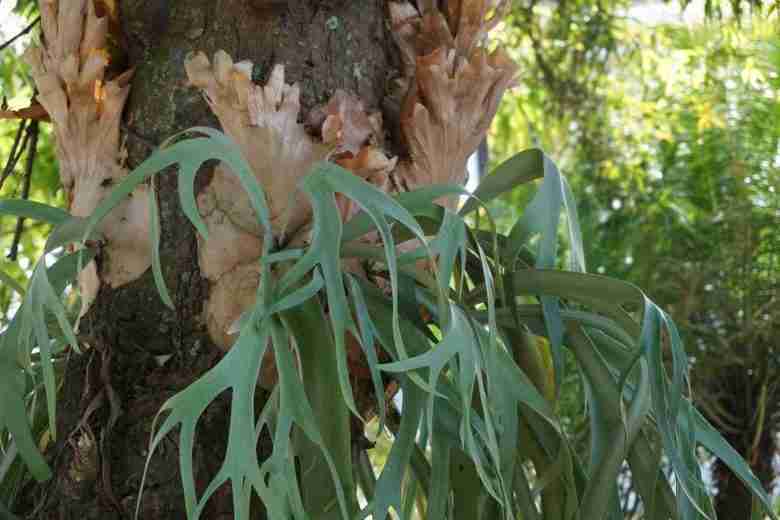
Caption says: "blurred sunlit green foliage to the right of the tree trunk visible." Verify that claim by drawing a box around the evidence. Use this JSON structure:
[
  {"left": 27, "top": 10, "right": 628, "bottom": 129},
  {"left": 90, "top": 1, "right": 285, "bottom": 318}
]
[{"left": 491, "top": 2, "right": 780, "bottom": 516}]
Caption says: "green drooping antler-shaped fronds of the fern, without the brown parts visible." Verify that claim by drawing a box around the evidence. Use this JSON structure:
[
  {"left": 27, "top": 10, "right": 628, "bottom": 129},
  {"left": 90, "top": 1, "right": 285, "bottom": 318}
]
[{"left": 0, "top": 128, "right": 772, "bottom": 520}]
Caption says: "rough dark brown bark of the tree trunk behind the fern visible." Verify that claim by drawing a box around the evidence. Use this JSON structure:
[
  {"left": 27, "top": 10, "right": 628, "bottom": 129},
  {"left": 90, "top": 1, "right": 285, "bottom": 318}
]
[{"left": 19, "top": 0, "right": 397, "bottom": 520}]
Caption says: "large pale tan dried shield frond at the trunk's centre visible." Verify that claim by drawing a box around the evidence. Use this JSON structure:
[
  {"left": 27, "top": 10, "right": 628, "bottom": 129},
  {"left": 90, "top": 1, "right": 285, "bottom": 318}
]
[{"left": 185, "top": 51, "right": 328, "bottom": 350}]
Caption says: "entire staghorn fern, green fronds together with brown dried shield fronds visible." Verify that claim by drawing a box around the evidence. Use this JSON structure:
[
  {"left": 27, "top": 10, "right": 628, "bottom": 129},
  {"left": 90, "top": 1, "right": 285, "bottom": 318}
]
[{"left": 0, "top": 0, "right": 768, "bottom": 520}]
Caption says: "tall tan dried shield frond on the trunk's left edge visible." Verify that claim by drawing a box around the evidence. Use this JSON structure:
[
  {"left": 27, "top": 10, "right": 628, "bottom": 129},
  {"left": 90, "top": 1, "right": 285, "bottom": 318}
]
[{"left": 24, "top": 0, "right": 151, "bottom": 311}]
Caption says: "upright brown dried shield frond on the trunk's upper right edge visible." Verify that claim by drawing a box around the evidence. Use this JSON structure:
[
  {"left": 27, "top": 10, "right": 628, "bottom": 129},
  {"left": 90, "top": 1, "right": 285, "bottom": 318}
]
[{"left": 390, "top": 0, "right": 517, "bottom": 206}]
